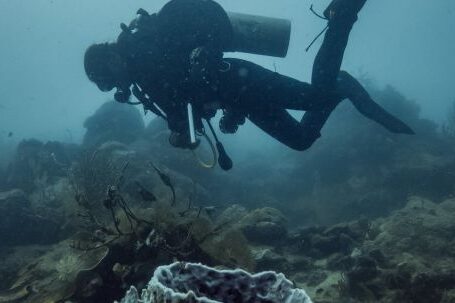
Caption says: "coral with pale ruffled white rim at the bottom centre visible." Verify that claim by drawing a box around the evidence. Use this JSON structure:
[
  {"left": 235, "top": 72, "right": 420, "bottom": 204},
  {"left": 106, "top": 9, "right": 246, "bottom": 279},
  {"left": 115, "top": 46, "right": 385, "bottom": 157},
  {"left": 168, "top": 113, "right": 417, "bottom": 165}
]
[{"left": 121, "top": 262, "right": 311, "bottom": 303}]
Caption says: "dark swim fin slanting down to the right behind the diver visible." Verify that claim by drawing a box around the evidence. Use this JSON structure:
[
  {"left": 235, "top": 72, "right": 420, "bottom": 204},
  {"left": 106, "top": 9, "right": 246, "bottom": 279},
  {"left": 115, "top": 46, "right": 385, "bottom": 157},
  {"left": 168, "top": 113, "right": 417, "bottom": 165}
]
[{"left": 337, "top": 71, "right": 414, "bottom": 135}]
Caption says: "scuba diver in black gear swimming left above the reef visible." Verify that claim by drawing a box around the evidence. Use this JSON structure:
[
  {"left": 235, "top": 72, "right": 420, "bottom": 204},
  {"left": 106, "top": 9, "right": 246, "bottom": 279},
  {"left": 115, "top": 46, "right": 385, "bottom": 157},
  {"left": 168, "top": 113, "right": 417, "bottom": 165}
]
[{"left": 84, "top": 0, "right": 414, "bottom": 170}]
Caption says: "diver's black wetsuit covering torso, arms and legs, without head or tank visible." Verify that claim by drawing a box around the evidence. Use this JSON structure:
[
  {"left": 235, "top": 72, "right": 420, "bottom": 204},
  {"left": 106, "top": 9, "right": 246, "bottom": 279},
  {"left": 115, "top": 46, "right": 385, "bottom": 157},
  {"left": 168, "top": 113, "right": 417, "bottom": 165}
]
[{"left": 118, "top": 0, "right": 412, "bottom": 150}]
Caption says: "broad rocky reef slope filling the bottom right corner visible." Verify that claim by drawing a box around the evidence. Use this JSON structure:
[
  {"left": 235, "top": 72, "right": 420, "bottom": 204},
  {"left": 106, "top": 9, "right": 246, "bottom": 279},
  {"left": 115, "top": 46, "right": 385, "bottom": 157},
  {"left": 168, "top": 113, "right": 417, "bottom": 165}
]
[{"left": 282, "top": 197, "right": 455, "bottom": 303}]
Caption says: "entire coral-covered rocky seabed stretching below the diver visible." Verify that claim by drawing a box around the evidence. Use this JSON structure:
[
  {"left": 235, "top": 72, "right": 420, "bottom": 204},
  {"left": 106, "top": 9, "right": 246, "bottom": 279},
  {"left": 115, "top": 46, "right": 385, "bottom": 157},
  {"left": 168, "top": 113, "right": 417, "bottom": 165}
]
[{"left": 0, "top": 88, "right": 455, "bottom": 303}]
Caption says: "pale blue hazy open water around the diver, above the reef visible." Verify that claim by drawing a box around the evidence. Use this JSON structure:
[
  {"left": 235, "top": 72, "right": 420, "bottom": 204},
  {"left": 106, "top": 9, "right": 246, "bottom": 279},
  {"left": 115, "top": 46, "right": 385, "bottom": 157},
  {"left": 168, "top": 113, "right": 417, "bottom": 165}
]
[{"left": 0, "top": 0, "right": 455, "bottom": 140}]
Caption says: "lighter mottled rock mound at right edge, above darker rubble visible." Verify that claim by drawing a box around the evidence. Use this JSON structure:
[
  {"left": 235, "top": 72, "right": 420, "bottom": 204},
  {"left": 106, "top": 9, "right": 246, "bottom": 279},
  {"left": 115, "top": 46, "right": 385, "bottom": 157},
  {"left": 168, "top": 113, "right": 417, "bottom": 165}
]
[{"left": 371, "top": 197, "right": 455, "bottom": 269}]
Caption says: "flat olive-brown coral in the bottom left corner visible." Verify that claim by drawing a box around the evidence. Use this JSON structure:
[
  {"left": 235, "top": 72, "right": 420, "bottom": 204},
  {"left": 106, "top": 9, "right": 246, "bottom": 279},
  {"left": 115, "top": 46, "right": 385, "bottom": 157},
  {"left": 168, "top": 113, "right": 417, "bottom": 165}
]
[{"left": 0, "top": 241, "right": 109, "bottom": 303}]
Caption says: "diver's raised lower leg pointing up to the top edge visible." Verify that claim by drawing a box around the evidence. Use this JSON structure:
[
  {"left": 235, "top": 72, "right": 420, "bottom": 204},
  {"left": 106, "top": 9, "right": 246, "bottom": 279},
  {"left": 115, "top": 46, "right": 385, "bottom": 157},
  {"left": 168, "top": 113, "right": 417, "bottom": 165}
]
[{"left": 311, "top": 0, "right": 366, "bottom": 92}]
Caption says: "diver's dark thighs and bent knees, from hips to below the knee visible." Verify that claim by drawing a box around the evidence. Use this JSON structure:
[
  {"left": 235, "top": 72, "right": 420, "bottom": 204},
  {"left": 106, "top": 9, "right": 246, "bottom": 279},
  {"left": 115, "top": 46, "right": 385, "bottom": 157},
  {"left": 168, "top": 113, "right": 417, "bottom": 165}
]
[{"left": 232, "top": 60, "right": 341, "bottom": 146}]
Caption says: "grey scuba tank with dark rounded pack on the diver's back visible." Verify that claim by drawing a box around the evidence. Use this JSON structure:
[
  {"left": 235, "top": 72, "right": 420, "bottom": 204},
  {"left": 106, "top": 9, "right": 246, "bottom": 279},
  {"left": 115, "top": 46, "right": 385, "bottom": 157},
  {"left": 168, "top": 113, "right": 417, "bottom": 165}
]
[{"left": 158, "top": 0, "right": 291, "bottom": 57}]
